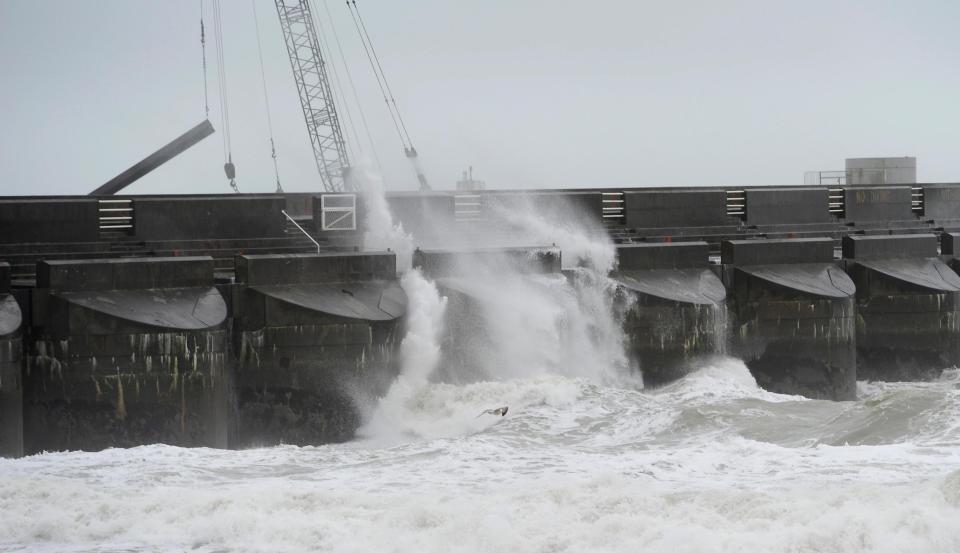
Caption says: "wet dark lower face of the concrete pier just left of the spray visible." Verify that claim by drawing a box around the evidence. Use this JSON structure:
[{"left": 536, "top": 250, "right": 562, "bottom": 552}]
[{"left": 231, "top": 321, "right": 401, "bottom": 447}]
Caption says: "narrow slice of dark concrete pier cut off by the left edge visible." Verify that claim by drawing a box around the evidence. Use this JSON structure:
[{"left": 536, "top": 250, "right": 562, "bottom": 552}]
[{"left": 0, "top": 263, "right": 23, "bottom": 457}]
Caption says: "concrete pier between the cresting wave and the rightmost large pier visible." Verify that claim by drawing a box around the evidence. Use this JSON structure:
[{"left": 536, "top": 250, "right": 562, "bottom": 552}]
[{"left": 722, "top": 238, "right": 857, "bottom": 400}]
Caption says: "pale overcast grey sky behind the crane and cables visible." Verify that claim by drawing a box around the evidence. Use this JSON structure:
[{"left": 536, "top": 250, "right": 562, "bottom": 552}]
[{"left": 0, "top": 0, "right": 960, "bottom": 195}]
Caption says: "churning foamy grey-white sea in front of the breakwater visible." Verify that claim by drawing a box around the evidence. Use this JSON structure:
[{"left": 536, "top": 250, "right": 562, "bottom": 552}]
[{"left": 0, "top": 360, "right": 960, "bottom": 553}]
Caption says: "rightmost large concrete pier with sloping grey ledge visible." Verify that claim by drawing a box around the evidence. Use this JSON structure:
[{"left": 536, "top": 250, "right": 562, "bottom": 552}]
[{"left": 843, "top": 234, "right": 960, "bottom": 380}]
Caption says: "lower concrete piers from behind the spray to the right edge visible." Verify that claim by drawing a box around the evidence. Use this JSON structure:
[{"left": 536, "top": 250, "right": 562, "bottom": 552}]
[{"left": 428, "top": 234, "right": 960, "bottom": 400}]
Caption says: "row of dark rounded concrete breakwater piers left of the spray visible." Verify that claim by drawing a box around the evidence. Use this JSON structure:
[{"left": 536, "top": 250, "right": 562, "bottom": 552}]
[{"left": 0, "top": 253, "right": 406, "bottom": 456}]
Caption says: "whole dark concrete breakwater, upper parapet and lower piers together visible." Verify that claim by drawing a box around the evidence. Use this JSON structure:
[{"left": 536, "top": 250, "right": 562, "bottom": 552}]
[{"left": 0, "top": 185, "right": 960, "bottom": 456}]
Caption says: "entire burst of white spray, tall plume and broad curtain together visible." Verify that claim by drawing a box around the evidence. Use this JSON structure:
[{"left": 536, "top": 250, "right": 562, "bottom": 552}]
[{"left": 355, "top": 175, "right": 643, "bottom": 437}]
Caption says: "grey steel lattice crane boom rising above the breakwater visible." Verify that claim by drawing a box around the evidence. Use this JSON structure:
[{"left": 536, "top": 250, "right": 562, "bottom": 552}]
[{"left": 275, "top": 0, "right": 353, "bottom": 192}]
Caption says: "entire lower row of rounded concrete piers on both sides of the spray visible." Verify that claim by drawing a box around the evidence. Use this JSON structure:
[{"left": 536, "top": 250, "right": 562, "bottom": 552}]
[{"left": 0, "top": 235, "right": 960, "bottom": 456}]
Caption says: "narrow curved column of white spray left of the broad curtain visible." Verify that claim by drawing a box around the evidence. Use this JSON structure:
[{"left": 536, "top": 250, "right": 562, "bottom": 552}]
[{"left": 358, "top": 269, "right": 447, "bottom": 439}]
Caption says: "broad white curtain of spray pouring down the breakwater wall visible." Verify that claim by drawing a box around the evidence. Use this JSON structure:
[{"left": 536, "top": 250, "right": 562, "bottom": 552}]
[{"left": 441, "top": 270, "right": 625, "bottom": 383}]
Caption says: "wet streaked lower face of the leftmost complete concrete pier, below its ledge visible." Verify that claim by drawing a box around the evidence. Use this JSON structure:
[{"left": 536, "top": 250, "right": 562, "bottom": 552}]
[{"left": 23, "top": 330, "right": 234, "bottom": 454}]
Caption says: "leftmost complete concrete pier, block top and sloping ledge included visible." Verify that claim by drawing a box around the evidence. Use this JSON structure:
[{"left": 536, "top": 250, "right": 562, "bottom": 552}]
[{"left": 24, "top": 257, "right": 231, "bottom": 453}]
